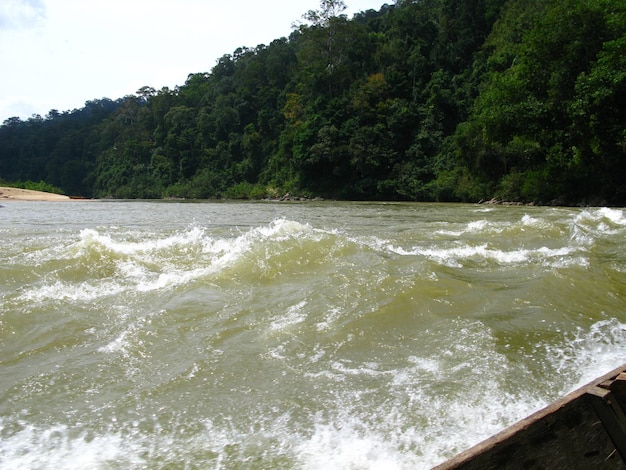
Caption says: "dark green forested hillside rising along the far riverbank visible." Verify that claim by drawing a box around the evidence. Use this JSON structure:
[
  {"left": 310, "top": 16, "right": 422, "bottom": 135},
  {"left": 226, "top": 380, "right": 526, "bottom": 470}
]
[{"left": 0, "top": 0, "right": 626, "bottom": 205}]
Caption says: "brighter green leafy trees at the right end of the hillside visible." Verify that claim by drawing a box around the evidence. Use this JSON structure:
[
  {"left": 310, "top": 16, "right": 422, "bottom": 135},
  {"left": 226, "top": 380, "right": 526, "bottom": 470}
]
[{"left": 457, "top": 0, "right": 626, "bottom": 204}]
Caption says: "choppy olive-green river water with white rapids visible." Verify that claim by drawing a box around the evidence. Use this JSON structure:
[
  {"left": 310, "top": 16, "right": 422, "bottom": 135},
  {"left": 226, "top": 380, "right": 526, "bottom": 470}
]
[{"left": 0, "top": 201, "right": 626, "bottom": 470}]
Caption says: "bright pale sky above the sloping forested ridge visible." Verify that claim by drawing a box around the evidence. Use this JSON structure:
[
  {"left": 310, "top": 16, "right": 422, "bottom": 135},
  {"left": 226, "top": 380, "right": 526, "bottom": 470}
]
[{"left": 0, "top": 0, "right": 386, "bottom": 124}]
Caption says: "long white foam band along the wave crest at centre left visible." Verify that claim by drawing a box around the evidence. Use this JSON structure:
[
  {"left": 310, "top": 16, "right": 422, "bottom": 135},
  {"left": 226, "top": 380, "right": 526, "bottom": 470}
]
[{"left": 43, "top": 219, "right": 315, "bottom": 294}]
